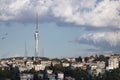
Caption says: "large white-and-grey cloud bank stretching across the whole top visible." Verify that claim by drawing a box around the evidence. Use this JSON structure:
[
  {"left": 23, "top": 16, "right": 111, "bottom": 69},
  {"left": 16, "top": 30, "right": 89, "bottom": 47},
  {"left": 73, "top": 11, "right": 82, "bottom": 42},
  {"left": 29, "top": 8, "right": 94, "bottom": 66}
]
[{"left": 0, "top": 0, "right": 120, "bottom": 28}]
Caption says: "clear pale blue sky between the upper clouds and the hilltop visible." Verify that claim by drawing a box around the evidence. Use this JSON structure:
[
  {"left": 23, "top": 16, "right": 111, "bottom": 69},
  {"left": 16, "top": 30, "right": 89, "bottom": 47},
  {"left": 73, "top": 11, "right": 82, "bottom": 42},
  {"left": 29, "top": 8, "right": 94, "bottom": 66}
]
[{"left": 0, "top": 23, "right": 91, "bottom": 58}]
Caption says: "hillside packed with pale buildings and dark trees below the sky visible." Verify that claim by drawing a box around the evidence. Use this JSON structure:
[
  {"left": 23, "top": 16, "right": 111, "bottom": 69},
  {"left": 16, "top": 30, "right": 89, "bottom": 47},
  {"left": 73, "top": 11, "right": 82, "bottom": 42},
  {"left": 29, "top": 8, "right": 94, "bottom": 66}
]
[{"left": 0, "top": 54, "right": 120, "bottom": 80}]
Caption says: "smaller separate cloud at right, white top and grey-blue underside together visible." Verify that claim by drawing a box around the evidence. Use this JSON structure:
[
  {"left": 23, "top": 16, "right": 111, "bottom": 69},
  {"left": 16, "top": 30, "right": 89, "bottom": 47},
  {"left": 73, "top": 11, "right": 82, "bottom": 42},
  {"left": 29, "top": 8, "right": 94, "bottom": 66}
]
[{"left": 77, "top": 32, "right": 120, "bottom": 53}]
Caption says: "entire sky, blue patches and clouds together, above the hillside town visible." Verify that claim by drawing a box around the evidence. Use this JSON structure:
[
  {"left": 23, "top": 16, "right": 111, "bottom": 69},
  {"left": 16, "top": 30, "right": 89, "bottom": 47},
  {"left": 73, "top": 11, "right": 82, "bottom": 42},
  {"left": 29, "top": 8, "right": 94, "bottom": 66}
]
[{"left": 0, "top": 0, "right": 120, "bottom": 58}]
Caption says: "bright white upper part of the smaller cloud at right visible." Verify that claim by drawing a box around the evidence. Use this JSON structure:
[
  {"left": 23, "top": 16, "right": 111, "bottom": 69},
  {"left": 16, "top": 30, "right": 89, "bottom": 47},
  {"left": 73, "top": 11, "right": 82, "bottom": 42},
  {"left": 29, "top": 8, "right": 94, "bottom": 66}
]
[{"left": 78, "top": 32, "right": 120, "bottom": 46}]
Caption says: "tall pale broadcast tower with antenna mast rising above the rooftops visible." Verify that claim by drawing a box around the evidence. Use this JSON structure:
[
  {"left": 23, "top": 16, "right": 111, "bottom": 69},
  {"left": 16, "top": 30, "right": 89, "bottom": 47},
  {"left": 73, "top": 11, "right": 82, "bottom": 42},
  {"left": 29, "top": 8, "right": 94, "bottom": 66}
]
[{"left": 34, "top": 15, "right": 39, "bottom": 60}]
